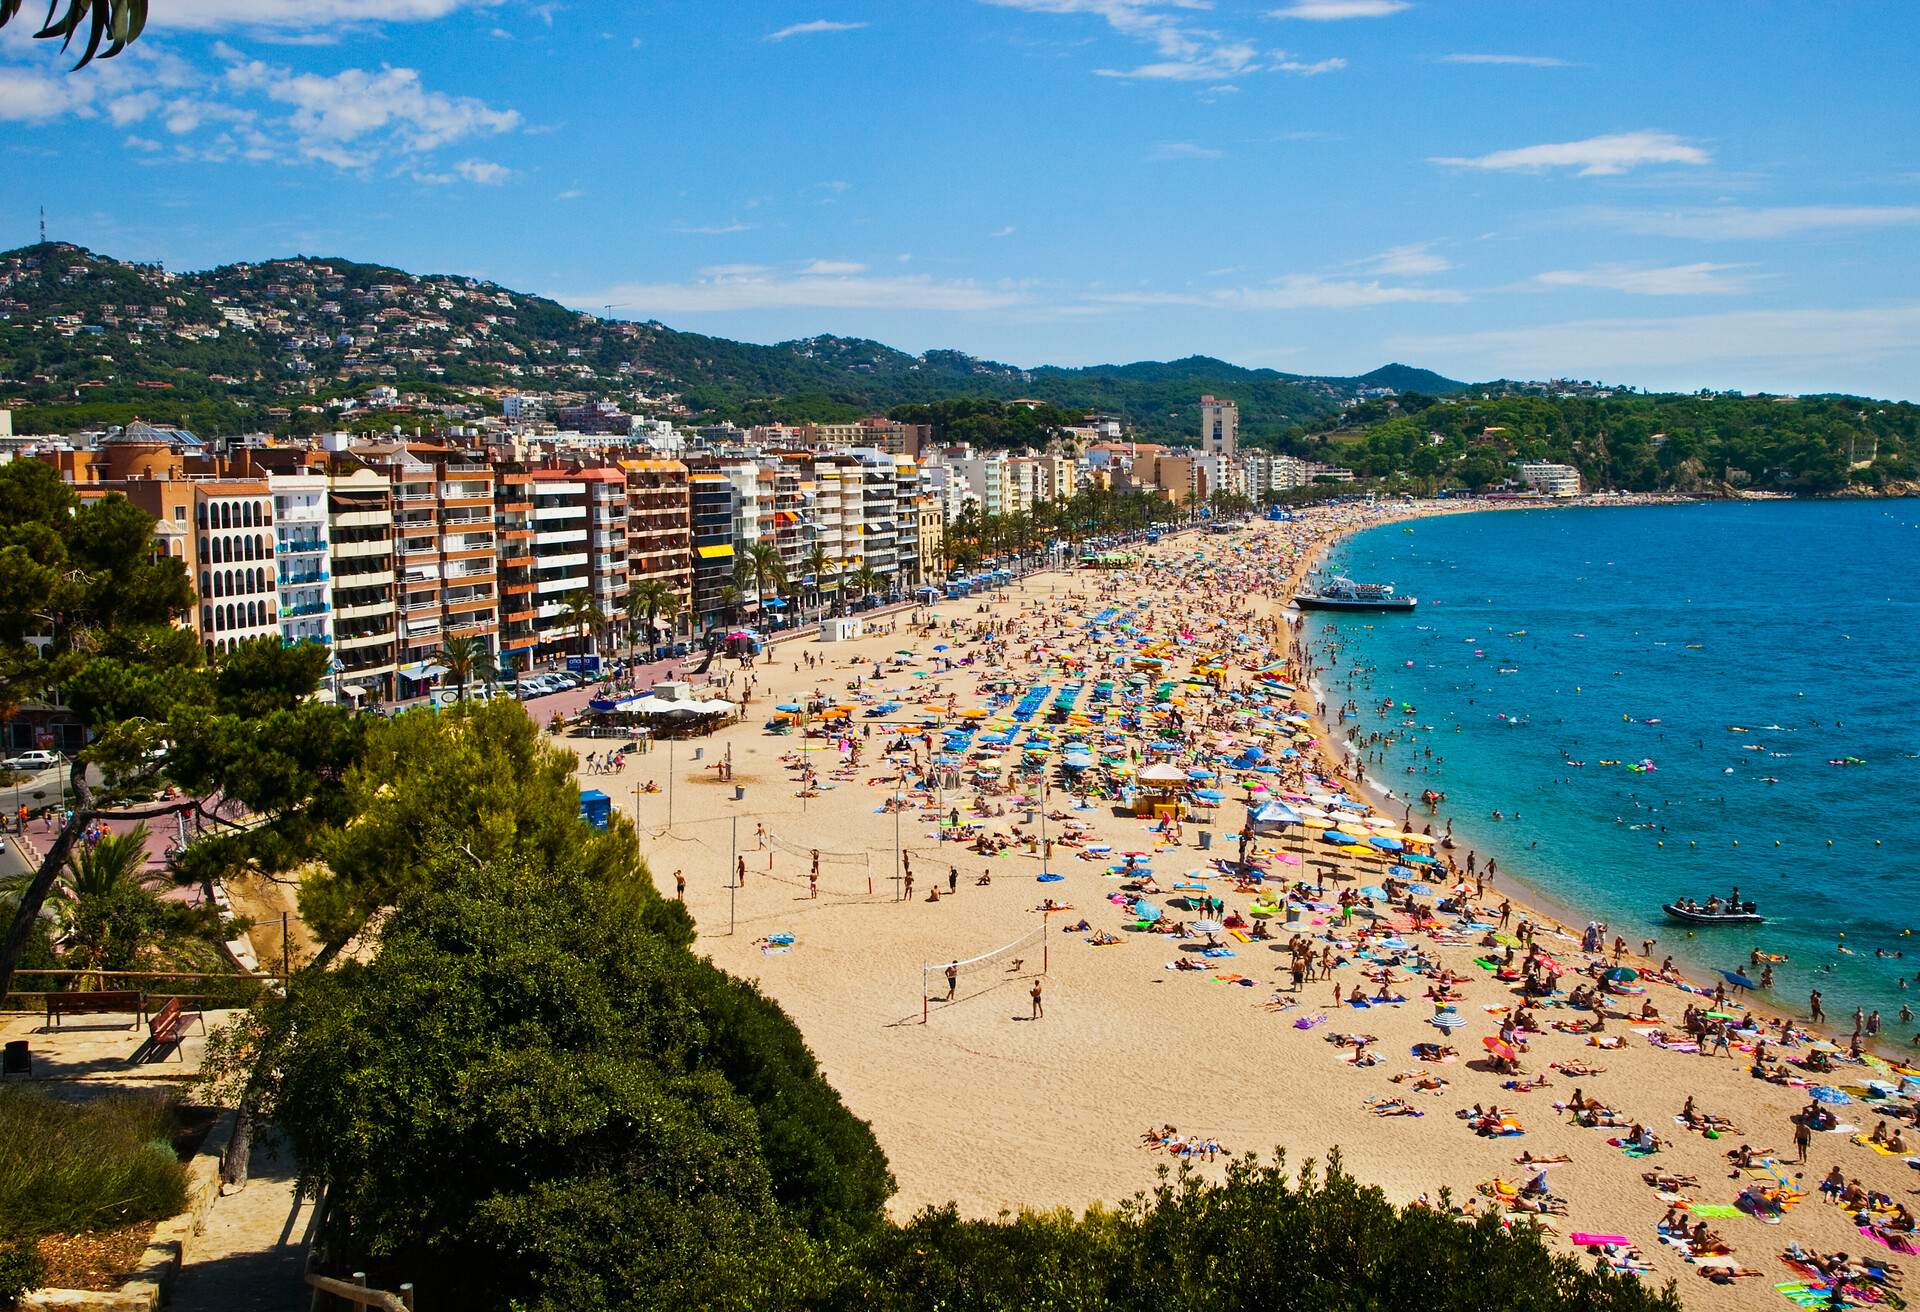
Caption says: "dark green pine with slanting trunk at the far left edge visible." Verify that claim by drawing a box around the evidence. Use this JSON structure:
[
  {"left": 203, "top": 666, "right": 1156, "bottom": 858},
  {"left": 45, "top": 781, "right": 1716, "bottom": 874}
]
[{"left": 0, "top": 461, "right": 198, "bottom": 995}]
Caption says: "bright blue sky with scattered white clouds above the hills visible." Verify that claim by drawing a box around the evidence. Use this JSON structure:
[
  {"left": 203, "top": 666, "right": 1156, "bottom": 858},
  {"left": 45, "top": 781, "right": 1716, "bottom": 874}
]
[{"left": 0, "top": 0, "right": 1920, "bottom": 398}]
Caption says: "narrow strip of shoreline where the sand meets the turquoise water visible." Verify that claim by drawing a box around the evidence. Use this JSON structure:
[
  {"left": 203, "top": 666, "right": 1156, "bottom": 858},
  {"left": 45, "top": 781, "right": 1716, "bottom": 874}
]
[{"left": 1281, "top": 498, "right": 1910, "bottom": 1062}]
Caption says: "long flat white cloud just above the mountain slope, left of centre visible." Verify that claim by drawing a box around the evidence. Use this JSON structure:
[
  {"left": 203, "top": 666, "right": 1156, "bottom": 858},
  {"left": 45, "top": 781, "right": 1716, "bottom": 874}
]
[{"left": 557, "top": 265, "right": 1027, "bottom": 315}]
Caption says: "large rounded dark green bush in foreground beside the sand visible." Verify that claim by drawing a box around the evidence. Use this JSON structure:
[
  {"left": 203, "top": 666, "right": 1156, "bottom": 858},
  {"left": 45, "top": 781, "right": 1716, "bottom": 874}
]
[{"left": 257, "top": 856, "right": 893, "bottom": 1312}]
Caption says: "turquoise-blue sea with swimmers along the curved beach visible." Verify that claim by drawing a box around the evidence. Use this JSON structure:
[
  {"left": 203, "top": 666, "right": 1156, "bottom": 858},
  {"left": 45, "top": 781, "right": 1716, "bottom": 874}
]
[{"left": 1308, "top": 499, "right": 1920, "bottom": 1043}]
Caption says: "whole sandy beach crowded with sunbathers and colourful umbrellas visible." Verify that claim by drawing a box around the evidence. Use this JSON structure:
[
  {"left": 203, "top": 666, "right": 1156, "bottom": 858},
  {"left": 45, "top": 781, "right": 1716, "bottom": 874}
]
[{"left": 563, "top": 507, "right": 1920, "bottom": 1308}]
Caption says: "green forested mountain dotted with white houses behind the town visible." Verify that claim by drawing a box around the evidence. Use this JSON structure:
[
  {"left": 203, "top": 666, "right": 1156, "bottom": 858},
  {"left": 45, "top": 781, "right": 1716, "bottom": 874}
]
[{"left": 0, "top": 242, "right": 1463, "bottom": 440}]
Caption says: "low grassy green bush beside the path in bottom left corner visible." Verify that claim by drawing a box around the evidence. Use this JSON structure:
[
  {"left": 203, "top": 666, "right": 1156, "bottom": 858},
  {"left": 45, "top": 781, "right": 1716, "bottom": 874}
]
[{"left": 0, "top": 1087, "right": 186, "bottom": 1241}]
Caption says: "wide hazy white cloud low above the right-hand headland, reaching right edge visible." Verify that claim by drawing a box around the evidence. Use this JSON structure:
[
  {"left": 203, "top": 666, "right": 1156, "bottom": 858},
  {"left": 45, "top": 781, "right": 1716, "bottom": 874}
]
[{"left": 1386, "top": 305, "right": 1920, "bottom": 386}]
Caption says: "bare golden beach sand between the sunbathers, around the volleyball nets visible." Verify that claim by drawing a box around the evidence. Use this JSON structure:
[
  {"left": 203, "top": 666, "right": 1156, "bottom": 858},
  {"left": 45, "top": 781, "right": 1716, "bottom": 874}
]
[{"left": 563, "top": 513, "right": 1920, "bottom": 1308}]
